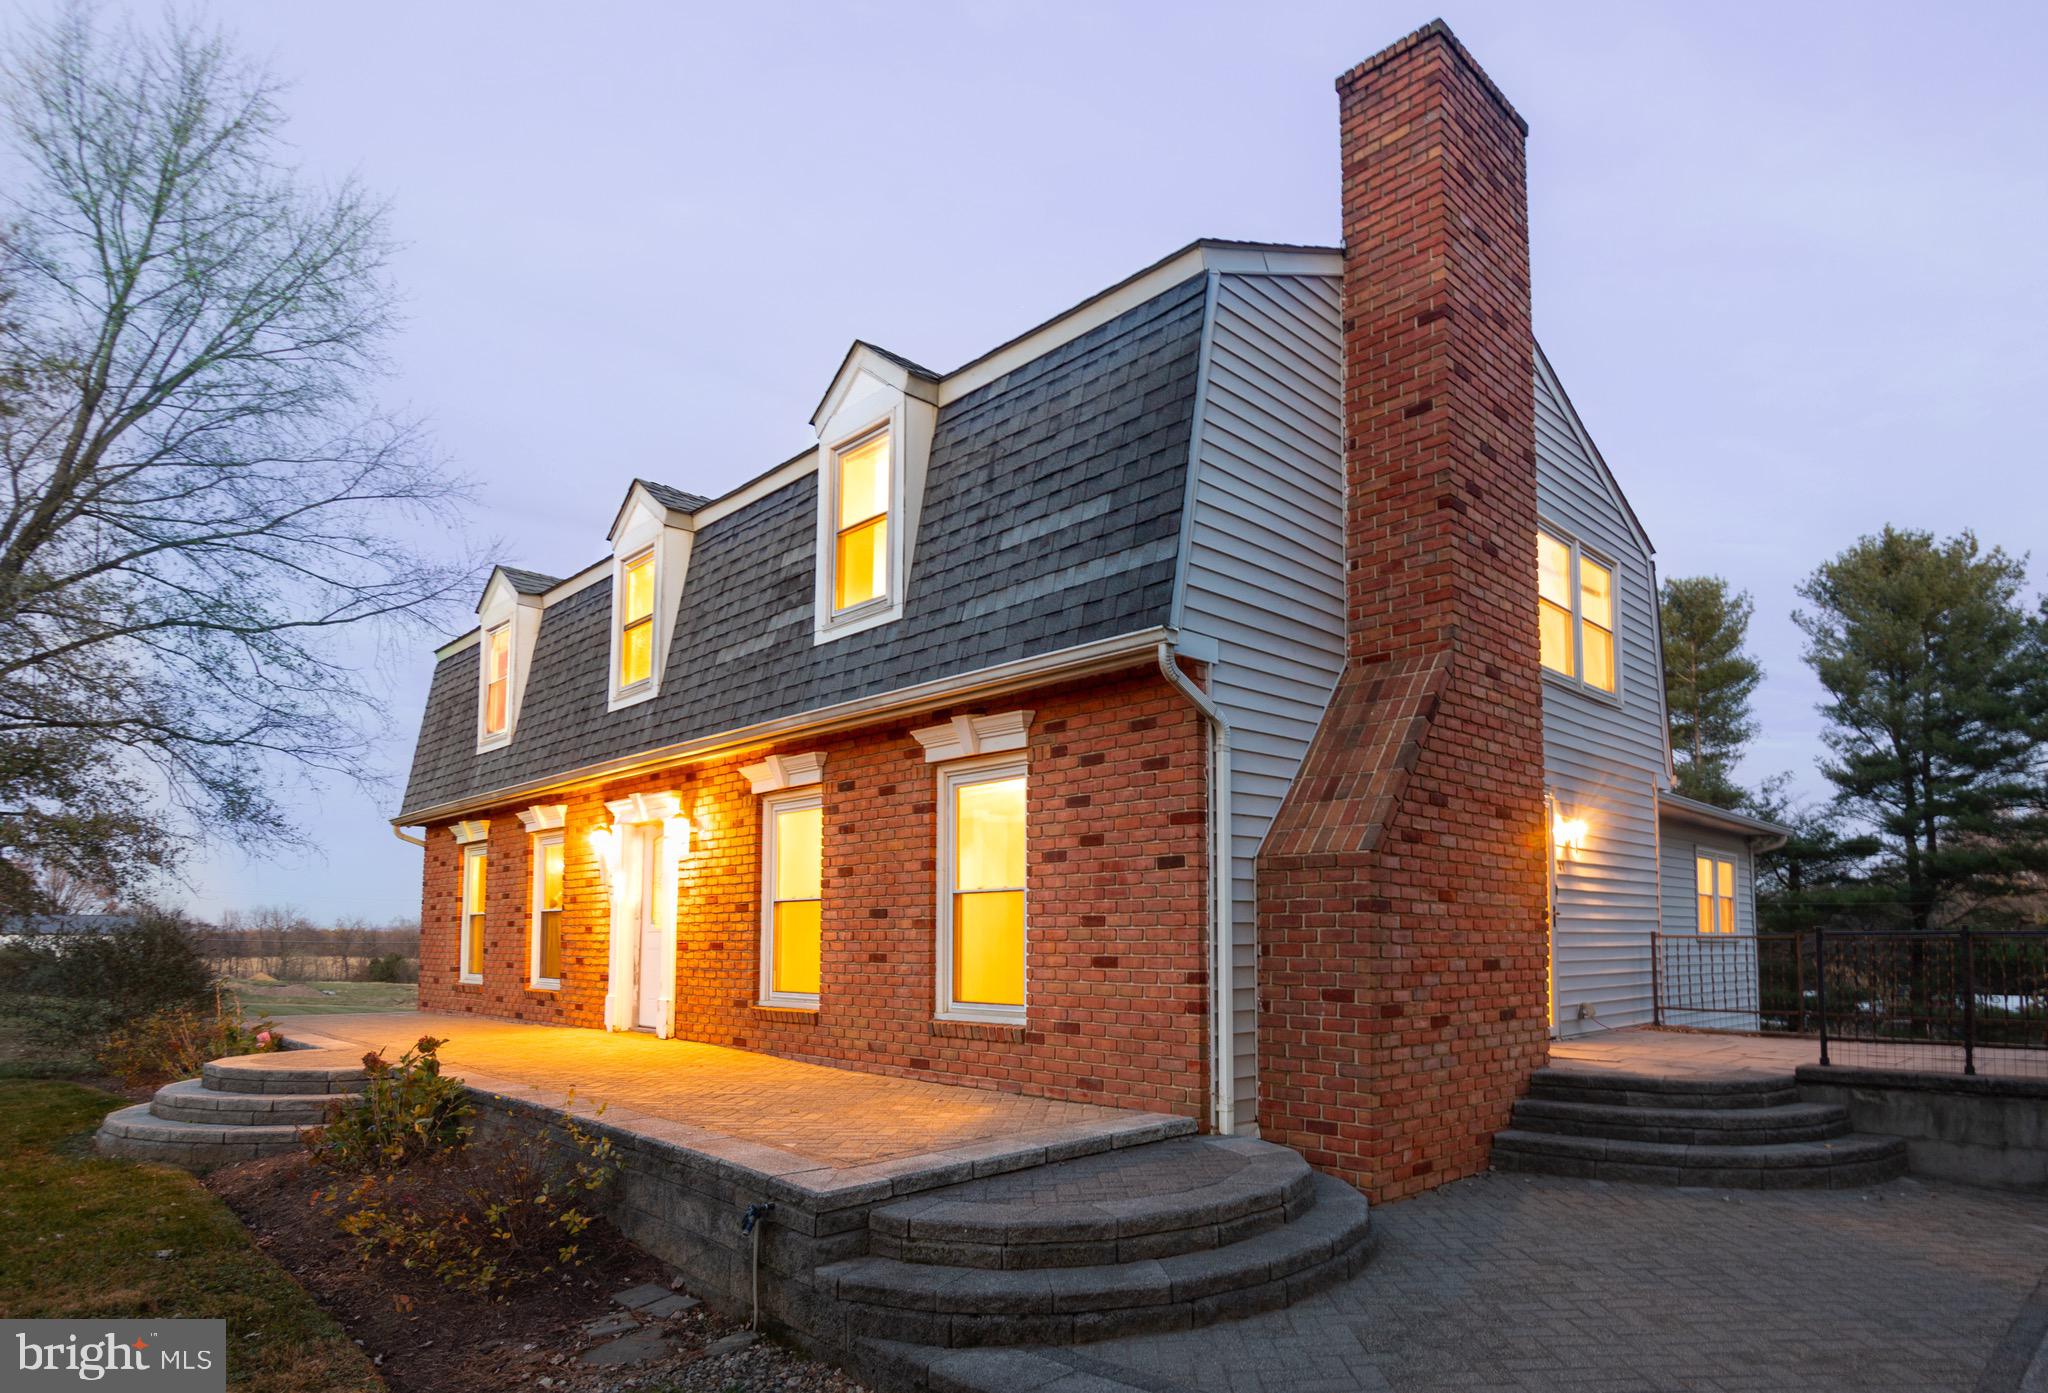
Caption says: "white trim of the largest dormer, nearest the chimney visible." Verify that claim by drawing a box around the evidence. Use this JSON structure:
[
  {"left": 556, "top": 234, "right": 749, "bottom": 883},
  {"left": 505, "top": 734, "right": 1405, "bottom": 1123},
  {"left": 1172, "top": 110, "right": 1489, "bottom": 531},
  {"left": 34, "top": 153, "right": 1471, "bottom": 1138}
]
[{"left": 811, "top": 344, "right": 938, "bottom": 643}]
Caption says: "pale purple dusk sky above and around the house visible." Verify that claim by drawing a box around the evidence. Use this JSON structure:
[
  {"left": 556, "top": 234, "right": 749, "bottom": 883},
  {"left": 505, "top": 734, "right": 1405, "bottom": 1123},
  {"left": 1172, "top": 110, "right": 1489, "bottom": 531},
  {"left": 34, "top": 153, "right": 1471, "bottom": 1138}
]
[{"left": 75, "top": 0, "right": 2048, "bottom": 918}]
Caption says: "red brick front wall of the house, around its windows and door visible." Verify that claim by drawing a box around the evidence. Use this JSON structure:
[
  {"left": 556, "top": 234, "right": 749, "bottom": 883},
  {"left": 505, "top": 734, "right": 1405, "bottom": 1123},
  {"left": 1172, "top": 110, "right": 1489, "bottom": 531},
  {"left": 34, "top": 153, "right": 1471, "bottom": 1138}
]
[{"left": 420, "top": 676, "right": 1208, "bottom": 1118}]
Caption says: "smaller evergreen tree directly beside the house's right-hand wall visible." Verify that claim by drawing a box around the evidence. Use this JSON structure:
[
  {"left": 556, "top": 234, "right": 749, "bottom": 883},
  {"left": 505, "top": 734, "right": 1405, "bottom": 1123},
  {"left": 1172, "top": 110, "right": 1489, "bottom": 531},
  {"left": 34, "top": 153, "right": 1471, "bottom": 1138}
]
[{"left": 1663, "top": 576, "right": 1763, "bottom": 807}]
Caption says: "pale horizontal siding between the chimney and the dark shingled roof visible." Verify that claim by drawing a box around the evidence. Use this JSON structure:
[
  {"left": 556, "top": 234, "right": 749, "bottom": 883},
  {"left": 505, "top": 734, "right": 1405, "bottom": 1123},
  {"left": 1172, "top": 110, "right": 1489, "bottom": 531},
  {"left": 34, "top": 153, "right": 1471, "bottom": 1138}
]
[{"left": 1176, "top": 275, "right": 1343, "bottom": 1131}]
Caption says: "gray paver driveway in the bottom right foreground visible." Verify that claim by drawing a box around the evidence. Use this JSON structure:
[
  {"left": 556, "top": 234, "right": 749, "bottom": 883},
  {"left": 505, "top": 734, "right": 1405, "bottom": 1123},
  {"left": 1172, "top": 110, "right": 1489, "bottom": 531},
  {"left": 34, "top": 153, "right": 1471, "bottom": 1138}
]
[{"left": 1069, "top": 1176, "right": 2048, "bottom": 1393}]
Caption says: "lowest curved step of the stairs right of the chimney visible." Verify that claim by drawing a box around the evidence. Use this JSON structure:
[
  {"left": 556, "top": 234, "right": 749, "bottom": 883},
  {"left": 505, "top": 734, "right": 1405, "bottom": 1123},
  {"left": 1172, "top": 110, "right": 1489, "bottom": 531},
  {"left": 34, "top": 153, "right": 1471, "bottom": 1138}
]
[{"left": 1493, "top": 1127, "right": 1907, "bottom": 1190}]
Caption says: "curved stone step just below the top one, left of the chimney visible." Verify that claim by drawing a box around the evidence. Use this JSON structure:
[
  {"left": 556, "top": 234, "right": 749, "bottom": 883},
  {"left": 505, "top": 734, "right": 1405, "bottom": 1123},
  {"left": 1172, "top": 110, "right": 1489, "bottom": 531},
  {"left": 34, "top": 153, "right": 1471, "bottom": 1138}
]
[{"left": 817, "top": 1176, "right": 1370, "bottom": 1348}]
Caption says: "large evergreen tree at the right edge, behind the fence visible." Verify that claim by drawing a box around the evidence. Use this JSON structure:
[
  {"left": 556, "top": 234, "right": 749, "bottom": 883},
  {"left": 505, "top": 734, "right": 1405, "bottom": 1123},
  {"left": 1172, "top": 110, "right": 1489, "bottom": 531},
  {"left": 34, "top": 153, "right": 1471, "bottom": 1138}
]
[{"left": 1794, "top": 526, "right": 2048, "bottom": 930}]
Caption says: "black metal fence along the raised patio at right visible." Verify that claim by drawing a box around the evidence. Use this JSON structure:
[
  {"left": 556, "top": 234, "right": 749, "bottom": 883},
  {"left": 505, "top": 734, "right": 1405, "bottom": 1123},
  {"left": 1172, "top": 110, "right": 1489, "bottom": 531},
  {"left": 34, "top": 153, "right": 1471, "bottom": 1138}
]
[{"left": 1651, "top": 928, "right": 2048, "bottom": 1078}]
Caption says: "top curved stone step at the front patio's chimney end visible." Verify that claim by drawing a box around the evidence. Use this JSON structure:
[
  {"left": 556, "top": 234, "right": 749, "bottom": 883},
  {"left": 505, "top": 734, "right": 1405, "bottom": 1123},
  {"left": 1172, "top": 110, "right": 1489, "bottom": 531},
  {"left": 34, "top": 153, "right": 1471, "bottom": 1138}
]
[{"left": 868, "top": 1137, "right": 1315, "bottom": 1268}]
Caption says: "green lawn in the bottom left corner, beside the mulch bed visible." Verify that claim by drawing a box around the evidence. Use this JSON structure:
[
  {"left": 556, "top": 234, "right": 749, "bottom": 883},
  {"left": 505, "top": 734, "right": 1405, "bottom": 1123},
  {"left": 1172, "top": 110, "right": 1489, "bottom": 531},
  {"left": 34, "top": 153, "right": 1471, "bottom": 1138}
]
[{"left": 0, "top": 1080, "right": 383, "bottom": 1393}]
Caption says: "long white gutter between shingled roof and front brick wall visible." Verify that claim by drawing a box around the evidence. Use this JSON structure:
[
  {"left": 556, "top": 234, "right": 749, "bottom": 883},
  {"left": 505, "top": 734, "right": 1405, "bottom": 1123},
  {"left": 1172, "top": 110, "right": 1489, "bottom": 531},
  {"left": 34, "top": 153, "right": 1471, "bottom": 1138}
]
[{"left": 391, "top": 625, "right": 1171, "bottom": 840}]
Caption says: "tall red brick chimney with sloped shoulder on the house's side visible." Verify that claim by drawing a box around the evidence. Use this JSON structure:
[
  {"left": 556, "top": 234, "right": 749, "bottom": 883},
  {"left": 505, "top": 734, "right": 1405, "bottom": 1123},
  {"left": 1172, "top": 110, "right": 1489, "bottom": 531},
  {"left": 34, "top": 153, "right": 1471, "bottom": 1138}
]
[{"left": 1260, "top": 20, "right": 1548, "bottom": 1198}]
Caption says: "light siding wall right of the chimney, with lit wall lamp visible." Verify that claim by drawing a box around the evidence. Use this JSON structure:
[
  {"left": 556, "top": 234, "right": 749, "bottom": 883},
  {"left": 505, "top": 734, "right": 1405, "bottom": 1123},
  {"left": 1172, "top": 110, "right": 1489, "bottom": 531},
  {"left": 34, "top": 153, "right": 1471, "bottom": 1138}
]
[{"left": 1530, "top": 354, "right": 1692, "bottom": 1035}]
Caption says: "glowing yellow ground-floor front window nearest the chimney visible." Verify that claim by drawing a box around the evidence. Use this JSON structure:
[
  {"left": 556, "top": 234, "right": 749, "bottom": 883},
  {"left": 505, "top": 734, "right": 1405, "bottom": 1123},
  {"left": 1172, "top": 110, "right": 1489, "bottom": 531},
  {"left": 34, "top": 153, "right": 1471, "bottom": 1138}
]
[{"left": 948, "top": 770, "right": 1024, "bottom": 1010}]
